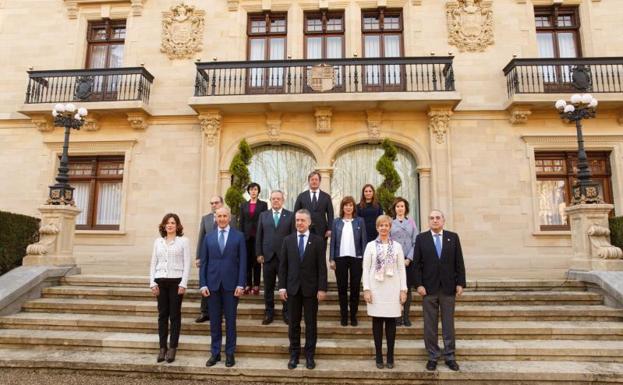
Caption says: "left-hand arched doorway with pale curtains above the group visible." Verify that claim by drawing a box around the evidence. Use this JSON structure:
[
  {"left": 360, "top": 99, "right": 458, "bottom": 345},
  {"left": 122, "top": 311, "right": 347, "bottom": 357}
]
[{"left": 249, "top": 145, "right": 316, "bottom": 210}]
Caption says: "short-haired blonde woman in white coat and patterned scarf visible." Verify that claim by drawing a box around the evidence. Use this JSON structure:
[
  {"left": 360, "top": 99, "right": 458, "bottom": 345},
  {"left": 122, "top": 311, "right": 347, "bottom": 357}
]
[{"left": 362, "top": 215, "right": 407, "bottom": 369}]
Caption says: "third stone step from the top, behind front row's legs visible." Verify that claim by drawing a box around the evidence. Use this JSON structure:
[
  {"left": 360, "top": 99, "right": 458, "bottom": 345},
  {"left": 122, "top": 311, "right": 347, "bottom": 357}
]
[{"left": 22, "top": 298, "right": 623, "bottom": 321}]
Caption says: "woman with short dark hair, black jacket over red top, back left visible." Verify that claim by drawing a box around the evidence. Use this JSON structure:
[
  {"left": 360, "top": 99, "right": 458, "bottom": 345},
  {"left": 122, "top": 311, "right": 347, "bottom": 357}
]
[{"left": 238, "top": 182, "right": 268, "bottom": 295}]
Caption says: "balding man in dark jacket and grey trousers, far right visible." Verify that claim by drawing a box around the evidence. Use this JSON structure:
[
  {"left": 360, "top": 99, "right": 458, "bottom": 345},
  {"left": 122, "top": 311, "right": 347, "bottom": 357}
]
[{"left": 413, "top": 210, "right": 466, "bottom": 371}]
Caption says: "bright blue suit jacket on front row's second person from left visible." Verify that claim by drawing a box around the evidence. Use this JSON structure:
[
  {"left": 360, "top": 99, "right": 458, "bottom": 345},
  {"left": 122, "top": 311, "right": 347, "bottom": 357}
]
[{"left": 199, "top": 227, "right": 247, "bottom": 291}]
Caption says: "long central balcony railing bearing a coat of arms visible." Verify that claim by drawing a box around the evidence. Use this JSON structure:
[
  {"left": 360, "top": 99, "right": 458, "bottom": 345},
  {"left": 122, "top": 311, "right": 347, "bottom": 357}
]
[{"left": 195, "top": 56, "right": 455, "bottom": 96}]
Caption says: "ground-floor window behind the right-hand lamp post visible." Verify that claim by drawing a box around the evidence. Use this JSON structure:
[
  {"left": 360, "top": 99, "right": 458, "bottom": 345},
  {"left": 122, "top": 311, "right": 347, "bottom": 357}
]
[{"left": 535, "top": 152, "right": 612, "bottom": 230}]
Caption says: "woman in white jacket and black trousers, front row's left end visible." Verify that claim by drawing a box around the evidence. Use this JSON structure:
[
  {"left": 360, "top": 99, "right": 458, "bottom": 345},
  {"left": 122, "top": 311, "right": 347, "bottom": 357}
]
[{"left": 149, "top": 213, "right": 191, "bottom": 362}]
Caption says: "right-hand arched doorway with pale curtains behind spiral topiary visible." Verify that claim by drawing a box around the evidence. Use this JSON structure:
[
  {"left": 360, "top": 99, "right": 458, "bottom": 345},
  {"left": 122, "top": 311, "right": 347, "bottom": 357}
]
[{"left": 331, "top": 144, "right": 420, "bottom": 226}]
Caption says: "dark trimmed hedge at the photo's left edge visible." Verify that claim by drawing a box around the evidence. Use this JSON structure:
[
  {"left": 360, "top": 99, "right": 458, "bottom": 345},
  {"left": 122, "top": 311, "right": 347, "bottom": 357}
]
[{"left": 0, "top": 211, "right": 39, "bottom": 275}]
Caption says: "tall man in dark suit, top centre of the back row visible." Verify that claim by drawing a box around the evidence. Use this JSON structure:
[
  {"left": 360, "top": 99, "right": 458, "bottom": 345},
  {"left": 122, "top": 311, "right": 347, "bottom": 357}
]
[{"left": 294, "top": 170, "right": 333, "bottom": 240}]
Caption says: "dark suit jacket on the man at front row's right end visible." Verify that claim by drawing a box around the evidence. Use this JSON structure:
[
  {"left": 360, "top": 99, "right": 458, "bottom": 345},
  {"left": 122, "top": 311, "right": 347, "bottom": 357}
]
[{"left": 413, "top": 230, "right": 466, "bottom": 295}]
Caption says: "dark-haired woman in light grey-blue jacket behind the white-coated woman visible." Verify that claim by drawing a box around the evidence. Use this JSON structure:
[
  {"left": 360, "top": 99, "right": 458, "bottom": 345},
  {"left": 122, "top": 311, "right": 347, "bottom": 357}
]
[{"left": 390, "top": 197, "right": 418, "bottom": 326}]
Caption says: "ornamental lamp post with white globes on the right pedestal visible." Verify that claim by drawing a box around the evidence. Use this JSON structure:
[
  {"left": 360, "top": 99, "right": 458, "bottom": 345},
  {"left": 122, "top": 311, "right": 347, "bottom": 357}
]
[{"left": 555, "top": 94, "right": 603, "bottom": 205}]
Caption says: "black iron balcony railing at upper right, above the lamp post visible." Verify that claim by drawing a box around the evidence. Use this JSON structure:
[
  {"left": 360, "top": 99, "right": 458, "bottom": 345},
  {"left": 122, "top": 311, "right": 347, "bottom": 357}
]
[{"left": 504, "top": 57, "right": 623, "bottom": 96}]
